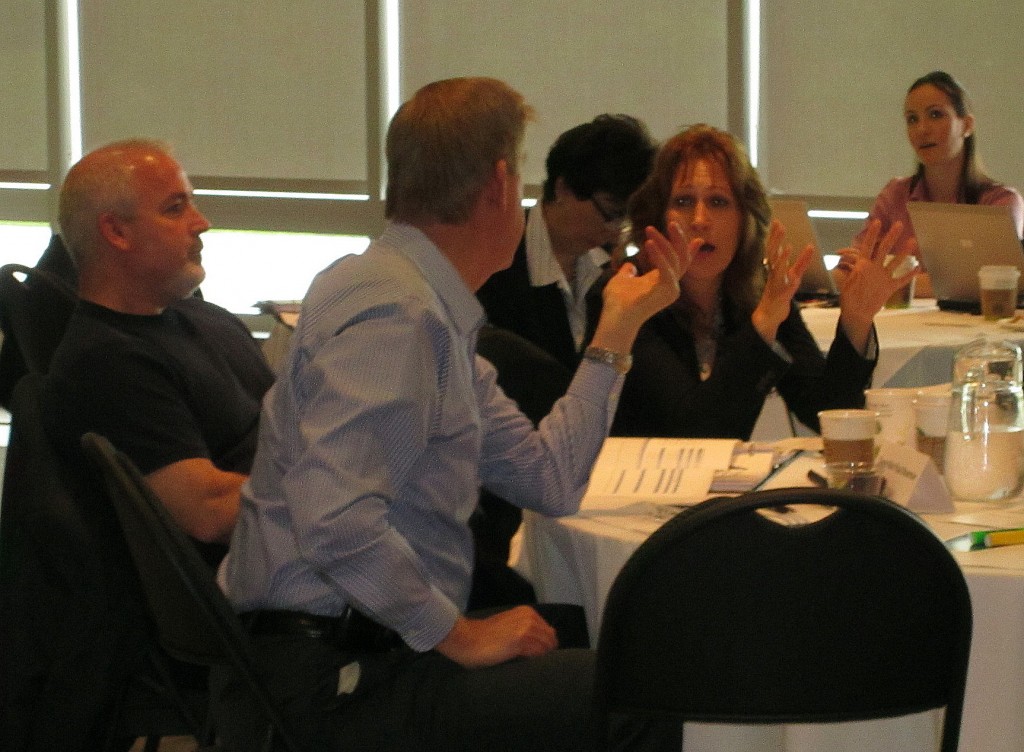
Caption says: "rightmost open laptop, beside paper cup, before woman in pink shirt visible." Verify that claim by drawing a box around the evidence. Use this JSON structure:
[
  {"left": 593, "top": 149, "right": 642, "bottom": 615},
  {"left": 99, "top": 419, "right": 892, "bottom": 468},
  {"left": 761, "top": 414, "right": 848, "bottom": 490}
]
[{"left": 906, "top": 201, "right": 1024, "bottom": 312}]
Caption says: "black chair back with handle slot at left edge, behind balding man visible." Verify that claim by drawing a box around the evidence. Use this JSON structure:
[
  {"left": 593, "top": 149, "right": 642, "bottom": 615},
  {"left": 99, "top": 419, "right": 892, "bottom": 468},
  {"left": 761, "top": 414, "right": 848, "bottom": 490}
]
[{"left": 0, "top": 263, "right": 78, "bottom": 373}]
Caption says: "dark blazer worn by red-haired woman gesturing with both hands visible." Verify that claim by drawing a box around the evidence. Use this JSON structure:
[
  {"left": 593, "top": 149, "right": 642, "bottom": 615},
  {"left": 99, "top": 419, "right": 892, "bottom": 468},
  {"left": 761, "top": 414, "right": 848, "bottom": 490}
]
[{"left": 611, "top": 305, "right": 874, "bottom": 441}]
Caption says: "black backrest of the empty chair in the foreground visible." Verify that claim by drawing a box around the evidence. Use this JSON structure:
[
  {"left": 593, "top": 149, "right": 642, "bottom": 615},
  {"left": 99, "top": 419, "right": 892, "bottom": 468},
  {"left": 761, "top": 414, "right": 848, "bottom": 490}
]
[{"left": 595, "top": 489, "right": 972, "bottom": 752}]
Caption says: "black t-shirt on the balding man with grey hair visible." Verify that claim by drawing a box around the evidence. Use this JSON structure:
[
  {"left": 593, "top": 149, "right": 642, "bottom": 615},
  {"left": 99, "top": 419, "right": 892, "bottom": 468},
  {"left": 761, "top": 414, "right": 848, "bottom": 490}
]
[{"left": 41, "top": 298, "right": 273, "bottom": 558}]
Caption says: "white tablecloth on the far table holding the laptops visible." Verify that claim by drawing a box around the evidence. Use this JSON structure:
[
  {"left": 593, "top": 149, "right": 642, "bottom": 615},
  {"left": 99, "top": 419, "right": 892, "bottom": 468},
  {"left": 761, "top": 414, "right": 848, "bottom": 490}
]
[{"left": 753, "top": 299, "right": 1024, "bottom": 442}]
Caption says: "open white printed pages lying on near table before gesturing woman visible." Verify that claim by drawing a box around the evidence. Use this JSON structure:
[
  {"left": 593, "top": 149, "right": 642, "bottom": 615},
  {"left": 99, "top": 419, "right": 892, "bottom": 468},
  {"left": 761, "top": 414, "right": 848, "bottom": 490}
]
[{"left": 580, "top": 436, "right": 757, "bottom": 514}]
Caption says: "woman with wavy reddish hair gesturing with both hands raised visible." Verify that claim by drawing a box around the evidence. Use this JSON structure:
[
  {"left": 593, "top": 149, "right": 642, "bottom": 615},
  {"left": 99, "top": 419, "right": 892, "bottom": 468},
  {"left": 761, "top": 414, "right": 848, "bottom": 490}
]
[{"left": 612, "top": 125, "right": 915, "bottom": 440}]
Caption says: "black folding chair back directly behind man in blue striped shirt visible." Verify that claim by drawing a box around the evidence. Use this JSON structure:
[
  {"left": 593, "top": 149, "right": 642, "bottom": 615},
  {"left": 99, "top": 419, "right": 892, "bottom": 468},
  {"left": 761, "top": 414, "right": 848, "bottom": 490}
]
[{"left": 82, "top": 433, "right": 298, "bottom": 750}]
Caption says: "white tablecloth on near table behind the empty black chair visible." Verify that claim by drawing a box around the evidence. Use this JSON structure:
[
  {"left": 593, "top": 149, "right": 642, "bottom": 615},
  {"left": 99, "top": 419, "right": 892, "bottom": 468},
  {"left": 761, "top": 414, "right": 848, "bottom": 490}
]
[{"left": 517, "top": 459, "right": 1024, "bottom": 752}]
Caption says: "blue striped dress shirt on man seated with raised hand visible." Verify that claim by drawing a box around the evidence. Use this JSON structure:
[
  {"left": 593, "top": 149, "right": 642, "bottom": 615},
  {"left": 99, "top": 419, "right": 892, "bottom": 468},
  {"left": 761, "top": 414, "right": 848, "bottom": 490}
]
[{"left": 219, "top": 223, "right": 622, "bottom": 651}]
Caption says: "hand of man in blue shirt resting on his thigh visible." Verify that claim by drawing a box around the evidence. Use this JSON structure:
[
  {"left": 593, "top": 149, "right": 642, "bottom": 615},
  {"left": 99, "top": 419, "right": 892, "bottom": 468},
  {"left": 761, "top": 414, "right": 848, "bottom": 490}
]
[{"left": 434, "top": 605, "right": 558, "bottom": 668}]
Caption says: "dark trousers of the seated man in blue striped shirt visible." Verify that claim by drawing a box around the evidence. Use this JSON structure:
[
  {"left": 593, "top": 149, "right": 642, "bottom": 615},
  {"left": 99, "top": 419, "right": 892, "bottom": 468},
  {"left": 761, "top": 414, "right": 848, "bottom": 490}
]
[{"left": 211, "top": 635, "right": 682, "bottom": 752}]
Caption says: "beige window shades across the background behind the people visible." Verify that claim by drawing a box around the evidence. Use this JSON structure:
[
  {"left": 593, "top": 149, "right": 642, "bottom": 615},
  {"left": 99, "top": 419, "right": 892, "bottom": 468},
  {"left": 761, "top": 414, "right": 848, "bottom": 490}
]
[{"left": 0, "top": 0, "right": 1024, "bottom": 238}]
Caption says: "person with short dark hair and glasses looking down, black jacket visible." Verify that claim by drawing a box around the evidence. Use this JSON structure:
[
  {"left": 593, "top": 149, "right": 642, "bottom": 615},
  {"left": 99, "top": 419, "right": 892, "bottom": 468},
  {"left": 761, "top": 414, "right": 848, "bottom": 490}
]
[{"left": 470, "top": 115, "right": 656, "bottom": 608}]
